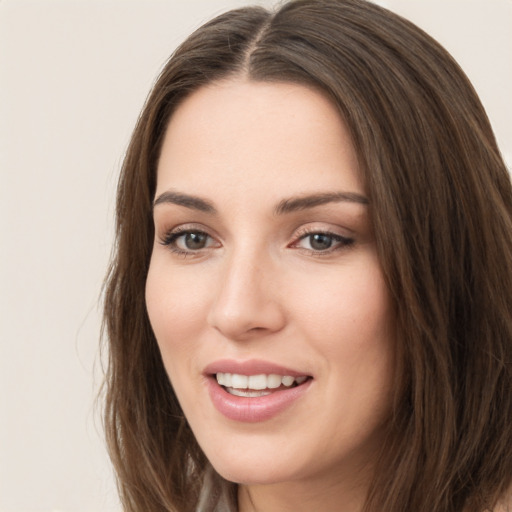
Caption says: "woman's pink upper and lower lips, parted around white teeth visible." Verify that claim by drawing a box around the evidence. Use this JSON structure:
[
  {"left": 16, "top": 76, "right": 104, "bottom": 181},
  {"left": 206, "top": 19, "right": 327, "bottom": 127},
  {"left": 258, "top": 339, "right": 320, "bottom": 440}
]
[{"left": 204, "top": 360, "right": 313, "bottom": 423}]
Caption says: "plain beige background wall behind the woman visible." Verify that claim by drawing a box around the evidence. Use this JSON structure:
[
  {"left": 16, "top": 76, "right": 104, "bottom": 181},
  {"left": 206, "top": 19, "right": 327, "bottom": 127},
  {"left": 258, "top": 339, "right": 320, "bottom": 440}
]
[{"left": 0, "top": 0, "right": 512, "bottom": 512}]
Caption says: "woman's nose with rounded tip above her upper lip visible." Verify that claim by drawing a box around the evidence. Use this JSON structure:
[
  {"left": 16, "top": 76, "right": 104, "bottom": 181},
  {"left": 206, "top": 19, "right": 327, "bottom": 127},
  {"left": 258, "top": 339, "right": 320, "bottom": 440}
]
[{"left": 208, "top": 247, "right": 286, "bottom": 341}]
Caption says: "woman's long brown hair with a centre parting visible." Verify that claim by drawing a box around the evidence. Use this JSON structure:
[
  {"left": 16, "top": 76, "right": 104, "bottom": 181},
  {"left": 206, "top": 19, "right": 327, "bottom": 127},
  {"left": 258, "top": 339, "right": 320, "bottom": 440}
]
[{"left": 104, "top": 0, "right": 512, "bottom": 512}]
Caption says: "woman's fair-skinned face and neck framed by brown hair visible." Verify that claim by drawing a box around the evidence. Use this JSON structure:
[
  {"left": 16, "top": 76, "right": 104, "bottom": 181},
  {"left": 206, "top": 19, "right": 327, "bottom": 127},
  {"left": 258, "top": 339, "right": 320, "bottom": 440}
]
[{"left": 146, "top": 78, "right": 395, "bottom": 512}]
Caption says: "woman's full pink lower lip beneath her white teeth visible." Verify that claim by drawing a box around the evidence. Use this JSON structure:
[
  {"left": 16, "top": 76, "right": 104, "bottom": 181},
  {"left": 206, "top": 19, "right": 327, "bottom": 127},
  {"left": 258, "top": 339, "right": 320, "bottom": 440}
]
[{"left": 208, "top": 377, "right": 312, "bottom": 423}]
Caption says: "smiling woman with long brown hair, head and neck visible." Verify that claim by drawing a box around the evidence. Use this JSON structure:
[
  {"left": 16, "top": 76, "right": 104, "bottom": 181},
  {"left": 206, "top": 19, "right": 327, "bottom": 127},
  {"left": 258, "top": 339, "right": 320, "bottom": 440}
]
[{"left": 105, "top": 0, "right": 512, "bottom": 512}]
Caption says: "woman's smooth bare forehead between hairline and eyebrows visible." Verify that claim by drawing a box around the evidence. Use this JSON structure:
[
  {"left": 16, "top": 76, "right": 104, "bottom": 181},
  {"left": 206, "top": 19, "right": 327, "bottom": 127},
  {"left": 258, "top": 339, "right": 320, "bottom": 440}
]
[{"left": 157, "top": 80, "right": 364, "bottom": 201}]
